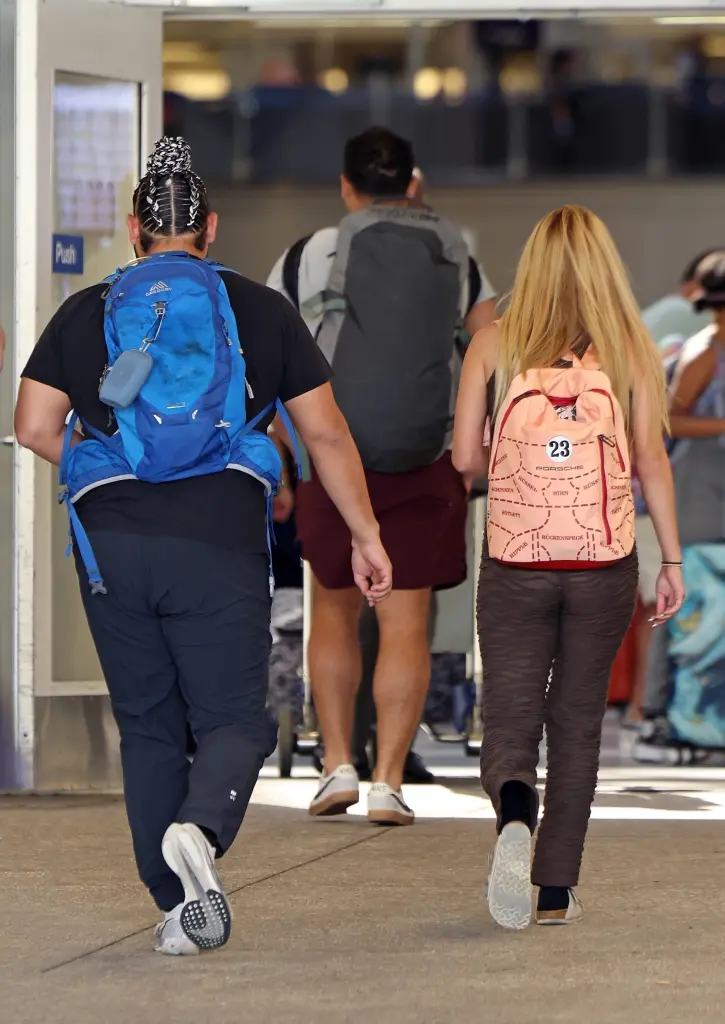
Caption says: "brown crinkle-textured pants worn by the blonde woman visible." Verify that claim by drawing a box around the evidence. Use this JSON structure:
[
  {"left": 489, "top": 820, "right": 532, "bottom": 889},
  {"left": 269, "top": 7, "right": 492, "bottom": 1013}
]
[{"left": 478, "top": 552, "right": 638, "bottom": 887}]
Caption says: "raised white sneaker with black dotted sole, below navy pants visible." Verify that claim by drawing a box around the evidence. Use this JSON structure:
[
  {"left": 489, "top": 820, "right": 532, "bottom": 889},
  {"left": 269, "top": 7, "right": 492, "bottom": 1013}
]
[{"left": 161, "top": 822, "right": 231, "bottom": 949}]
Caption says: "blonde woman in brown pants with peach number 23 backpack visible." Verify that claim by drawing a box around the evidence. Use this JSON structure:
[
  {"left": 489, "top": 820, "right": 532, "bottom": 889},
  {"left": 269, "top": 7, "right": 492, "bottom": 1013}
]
[{"left": 453, "top": 207, "right": 684, "bottom": 929}]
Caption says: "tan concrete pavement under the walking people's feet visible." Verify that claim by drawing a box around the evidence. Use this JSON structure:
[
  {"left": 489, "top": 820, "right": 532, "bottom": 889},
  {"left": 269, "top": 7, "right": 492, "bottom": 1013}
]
[{"left": 0, "top": 797, "right": 725, "bottom": 1024}]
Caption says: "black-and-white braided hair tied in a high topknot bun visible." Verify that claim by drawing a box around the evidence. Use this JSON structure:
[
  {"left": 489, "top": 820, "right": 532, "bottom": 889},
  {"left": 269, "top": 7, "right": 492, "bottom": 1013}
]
[{"left": 133, "top": 136, "right": 209, "bottom": 252}]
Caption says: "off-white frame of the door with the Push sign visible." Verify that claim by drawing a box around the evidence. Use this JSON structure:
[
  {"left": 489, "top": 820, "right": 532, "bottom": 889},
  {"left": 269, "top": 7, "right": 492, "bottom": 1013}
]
[{"left": 13, "top": 0, "right": 163, "bottom": 790}]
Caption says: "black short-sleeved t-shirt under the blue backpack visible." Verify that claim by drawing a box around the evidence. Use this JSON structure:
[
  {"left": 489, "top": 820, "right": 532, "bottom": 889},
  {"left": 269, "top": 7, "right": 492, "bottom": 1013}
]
[{"left": 23, "top": 271, "right": 331, "bottom": 553}]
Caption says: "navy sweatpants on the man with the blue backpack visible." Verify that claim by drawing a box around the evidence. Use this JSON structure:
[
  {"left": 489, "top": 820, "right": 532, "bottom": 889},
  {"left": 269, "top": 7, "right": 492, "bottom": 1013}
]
[{"left": 78, "top": 532, "right": 276, "bottom": 910}]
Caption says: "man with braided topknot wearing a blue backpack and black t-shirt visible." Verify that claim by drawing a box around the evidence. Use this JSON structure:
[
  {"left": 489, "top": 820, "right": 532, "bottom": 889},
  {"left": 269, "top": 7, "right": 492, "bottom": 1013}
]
[{"left": 15, "top": 138, "right": 391, "bottom": 955}]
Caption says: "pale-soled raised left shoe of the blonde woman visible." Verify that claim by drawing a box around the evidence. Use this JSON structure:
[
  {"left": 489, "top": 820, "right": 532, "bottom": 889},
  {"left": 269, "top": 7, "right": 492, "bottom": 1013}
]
[{"left": 488, "top": 821, "right": 532, "bottom": 932}]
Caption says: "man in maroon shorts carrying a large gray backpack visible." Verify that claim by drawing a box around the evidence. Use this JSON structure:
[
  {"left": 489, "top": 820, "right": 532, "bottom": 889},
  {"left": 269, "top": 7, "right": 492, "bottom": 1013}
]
[{"left": 268, "top": 129, "right": 493, "bottom": 824}]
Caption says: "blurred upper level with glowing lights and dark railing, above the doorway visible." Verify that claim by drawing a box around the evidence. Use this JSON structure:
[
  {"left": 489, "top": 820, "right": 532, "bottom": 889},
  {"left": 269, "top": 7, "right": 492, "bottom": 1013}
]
[{"left": 164, "top": 13, "right": 725, "bottom": 186}]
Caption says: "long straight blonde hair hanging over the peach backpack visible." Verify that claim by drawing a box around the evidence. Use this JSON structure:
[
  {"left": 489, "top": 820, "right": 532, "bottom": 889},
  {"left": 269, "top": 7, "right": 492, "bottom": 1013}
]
[{"left": 495, "top": 206, "right": 669, "bottom": 437}]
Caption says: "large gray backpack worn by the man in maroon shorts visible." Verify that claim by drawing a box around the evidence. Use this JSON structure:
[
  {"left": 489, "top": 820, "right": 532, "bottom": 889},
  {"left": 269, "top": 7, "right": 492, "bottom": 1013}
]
[{"left": 286, "top": 204, "right": 477, "bottom": 473}]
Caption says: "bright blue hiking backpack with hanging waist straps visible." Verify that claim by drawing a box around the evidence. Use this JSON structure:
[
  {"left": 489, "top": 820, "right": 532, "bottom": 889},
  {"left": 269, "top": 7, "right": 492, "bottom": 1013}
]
[{"left": 59, "top": 252, "right": 295, "bottom": 594}]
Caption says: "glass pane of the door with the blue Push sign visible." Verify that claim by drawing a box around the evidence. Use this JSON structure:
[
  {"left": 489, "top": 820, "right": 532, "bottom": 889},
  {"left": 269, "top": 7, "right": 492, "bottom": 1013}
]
[{"left": 48, "top": 71, "right": 141, "bottom": 696}]
